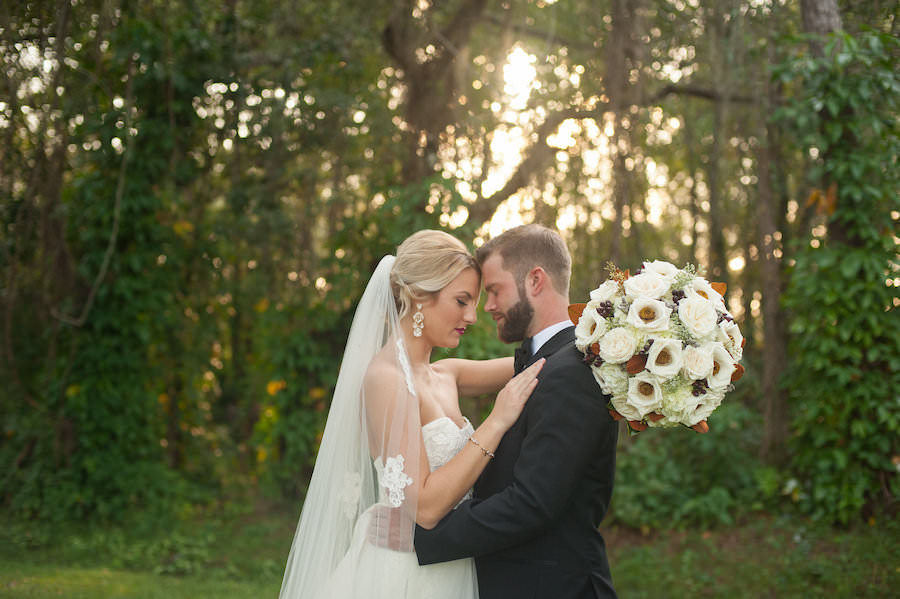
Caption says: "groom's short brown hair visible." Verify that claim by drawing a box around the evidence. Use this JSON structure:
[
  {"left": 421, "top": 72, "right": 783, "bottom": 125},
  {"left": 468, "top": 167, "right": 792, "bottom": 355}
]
[{"left": 475, "top": 224, "right": 572, "bottom": 297}]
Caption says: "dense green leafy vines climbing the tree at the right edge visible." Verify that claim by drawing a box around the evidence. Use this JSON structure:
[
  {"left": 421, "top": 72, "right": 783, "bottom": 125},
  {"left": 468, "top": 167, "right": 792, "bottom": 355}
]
[{"left": 776, "top": 33, "right": 900, "bottom": 523}]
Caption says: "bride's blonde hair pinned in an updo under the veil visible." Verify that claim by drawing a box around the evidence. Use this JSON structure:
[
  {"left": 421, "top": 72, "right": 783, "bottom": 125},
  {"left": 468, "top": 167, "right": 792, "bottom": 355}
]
[{"left": 391, "top": 229, "right": 481, "bottom": 318}]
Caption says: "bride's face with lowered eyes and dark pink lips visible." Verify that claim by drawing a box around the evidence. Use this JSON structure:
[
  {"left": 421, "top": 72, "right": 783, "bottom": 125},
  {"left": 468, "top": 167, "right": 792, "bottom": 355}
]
[{"left": 422, "top": 268, "right": 481, "bottom": 347}]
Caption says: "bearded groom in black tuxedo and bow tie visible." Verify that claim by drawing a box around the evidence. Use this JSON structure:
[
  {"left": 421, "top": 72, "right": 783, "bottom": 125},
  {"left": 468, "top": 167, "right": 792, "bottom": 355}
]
[{"left": 415, "top": 225, "right": 618, "bottom": 599}]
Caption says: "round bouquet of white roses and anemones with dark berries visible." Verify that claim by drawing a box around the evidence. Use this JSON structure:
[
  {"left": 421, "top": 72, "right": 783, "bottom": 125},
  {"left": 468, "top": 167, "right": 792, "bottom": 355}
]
[{"left": 569, "top": 260, "right": 744, "bottom": 432}]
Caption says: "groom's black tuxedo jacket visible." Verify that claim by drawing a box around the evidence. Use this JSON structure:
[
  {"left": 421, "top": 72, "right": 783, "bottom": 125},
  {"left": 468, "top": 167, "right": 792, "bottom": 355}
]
[{"left": 415, "top": 327, "right": 618, "bottom": 599}]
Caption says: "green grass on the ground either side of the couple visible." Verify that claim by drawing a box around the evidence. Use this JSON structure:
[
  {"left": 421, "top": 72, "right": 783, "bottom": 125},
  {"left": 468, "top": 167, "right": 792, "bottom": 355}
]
[{"left": 0, "top": 509, "right": 900, "bottom": 599}]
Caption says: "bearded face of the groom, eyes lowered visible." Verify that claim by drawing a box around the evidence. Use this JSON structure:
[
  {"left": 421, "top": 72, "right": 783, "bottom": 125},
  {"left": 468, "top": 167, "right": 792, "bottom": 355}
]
[{"left": 481, "top": 253, "right": 534, "bottom": 343}]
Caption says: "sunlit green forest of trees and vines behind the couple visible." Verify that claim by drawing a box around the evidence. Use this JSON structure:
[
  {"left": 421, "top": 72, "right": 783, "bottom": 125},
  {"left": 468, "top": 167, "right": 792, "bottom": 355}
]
[{"left": 0, "top": 0, "right": 900, "bottom": 596}]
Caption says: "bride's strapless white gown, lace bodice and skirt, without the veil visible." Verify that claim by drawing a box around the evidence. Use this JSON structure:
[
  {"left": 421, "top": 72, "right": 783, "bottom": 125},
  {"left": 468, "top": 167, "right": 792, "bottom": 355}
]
[{"left": 319, "top": 416, "right": 478, "bottom": 599}]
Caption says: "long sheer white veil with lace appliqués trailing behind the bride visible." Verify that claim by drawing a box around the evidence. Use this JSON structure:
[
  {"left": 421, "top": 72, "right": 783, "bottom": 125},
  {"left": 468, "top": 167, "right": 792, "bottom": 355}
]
[{"left": 279, "top": 256, "right": 425, "bottom": 599}]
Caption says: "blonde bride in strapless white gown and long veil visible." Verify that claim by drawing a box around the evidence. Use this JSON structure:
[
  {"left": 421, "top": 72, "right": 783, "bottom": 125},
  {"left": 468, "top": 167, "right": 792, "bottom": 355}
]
[{"left": 279, "top": 230, "right": 543, "bottom": 599}]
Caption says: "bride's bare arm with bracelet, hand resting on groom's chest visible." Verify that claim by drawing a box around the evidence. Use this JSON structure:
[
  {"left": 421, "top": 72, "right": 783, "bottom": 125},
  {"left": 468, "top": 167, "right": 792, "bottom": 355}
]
[{"left": 365, "top": 360, "right": 544, "bottom": 528}]
